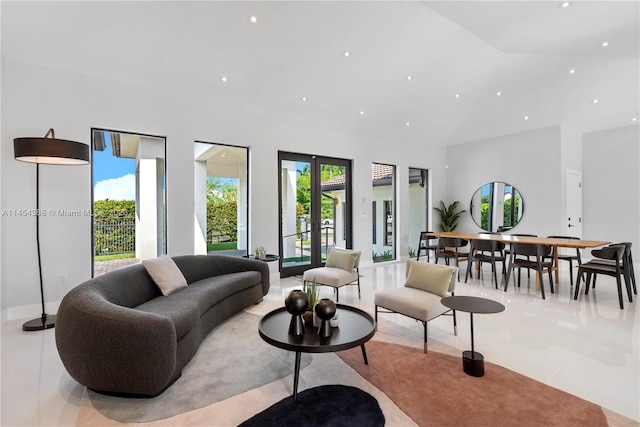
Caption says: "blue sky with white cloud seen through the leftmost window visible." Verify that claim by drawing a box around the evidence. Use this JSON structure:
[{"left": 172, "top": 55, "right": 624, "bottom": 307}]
[{"left": 93, "top": 132, "right": 136, "bottom": 200}]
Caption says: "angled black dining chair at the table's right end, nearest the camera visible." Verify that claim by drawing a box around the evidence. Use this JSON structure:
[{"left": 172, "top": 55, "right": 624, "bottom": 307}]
[{"left": 573, "top": 244, "right": 633, "bottom": 310}]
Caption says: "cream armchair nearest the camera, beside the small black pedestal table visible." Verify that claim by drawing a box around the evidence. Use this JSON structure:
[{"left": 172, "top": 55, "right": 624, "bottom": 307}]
[{"left": 374, "top": 260, "right": 458, "bottom": 353}]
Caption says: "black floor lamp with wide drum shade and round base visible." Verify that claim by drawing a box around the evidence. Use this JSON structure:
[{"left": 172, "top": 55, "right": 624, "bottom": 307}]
[{"left": 13, "top": 129, "right": 89, "bottom": 331}]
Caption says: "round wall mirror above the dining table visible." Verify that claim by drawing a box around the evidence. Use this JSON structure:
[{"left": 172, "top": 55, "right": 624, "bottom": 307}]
[{"left": 469, "top": 181, "right": 524, "bottom": 233}]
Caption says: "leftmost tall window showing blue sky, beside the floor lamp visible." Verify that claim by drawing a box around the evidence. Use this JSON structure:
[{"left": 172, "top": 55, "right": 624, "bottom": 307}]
[{"left": 92, "top": 129, "right": 167, "bottom": 276}]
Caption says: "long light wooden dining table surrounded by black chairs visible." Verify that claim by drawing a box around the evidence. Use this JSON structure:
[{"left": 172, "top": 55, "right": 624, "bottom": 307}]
[{"left": 429, "top": 231, "right": 611, "bottom": 289}]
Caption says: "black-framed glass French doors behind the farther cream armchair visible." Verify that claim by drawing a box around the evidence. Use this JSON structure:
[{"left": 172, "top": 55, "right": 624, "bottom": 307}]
[{"left": 278, "top": 152, "right": 352, "bottom": 277}]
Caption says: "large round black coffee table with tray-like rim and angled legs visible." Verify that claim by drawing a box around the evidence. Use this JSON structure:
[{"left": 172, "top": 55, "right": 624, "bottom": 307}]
[{"left": 258, "top": 304, "right": 376, "bottom": 400}]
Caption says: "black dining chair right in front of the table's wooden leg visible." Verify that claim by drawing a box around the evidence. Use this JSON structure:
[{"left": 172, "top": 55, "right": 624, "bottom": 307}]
[{"left": 504, "top": 242, "right": 554, "bottom": 299}]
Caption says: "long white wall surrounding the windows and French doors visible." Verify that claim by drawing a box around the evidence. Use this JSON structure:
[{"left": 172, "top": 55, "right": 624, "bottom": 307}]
[{"left": 0, "top": 60, "right": 446, "bottom": 320}]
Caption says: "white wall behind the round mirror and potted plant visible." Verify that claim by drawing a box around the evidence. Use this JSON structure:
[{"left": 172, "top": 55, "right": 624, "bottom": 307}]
[{"left": 444, "top": 126, "right": 563, "bottom": 236}]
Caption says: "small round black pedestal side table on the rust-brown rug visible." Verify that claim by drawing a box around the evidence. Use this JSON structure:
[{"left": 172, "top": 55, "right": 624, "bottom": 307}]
[{"left": 440, "top": 295, "right": 504, "bottom": 377}]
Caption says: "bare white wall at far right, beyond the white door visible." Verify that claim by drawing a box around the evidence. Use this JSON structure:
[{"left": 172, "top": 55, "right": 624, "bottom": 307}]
[{"left": 582, "top": 125, "right": 640, "bottom": 263}]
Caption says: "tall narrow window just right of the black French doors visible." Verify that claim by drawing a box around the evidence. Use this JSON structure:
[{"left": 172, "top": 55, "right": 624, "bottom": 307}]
[{"left": 371, "top": 163, "right": 396, "bottom": 262}]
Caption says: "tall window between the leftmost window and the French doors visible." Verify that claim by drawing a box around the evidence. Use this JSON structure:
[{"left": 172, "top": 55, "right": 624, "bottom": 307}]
[{"left": 194, "top": 142, "right": 249, "bottom": 256}]
